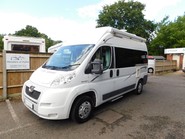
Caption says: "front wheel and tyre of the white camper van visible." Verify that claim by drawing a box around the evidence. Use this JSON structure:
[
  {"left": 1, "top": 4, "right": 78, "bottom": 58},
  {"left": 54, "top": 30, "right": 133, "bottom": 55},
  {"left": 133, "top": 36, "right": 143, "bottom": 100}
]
[{"left": 70, "top": 96, "right": 94, "bottom": 123}]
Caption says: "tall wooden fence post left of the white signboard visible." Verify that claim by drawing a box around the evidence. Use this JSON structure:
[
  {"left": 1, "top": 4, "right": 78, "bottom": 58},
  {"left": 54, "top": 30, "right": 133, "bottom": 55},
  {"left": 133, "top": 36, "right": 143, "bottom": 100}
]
[{"left": 3, "top": 50, "right": 7, "bottom": 99}]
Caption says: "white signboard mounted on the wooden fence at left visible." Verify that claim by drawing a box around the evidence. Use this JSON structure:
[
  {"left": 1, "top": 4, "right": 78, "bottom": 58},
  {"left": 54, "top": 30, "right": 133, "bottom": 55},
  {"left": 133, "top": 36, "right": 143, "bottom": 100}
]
[{"left": 6, "top": 53, "right": 30, "bottom": 70}]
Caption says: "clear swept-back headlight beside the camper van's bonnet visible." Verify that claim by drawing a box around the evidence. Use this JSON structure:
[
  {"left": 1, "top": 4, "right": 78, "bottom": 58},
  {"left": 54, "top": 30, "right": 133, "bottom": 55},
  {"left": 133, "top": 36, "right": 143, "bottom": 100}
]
[{"left": 51, "top": 73, "right": 76, "bottom": 87}]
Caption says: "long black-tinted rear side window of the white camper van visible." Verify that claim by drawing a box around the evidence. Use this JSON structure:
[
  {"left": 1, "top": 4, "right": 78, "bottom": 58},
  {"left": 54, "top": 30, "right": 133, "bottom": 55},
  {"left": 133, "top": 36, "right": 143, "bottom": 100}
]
[{"left": 115, "top": 47, "right": 147, "bottom": 68}]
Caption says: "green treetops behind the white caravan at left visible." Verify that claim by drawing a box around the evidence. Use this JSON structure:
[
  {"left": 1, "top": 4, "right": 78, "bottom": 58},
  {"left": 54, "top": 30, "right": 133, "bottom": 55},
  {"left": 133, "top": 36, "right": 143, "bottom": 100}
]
[{"left": 14, "top": 25, "right": 61, "bottom": 50}]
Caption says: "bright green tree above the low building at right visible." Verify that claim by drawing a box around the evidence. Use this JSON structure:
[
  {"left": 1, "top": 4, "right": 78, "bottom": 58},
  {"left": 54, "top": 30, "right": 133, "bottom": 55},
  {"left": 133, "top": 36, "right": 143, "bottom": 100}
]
[{"left": 149, "top": 14, "right": 185, "bottom": 55}]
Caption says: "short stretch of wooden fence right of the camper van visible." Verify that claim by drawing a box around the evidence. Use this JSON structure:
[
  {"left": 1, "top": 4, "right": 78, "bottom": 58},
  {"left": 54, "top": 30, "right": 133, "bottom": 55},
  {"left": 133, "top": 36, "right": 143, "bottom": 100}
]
[{"left": 155, "top": 60, "right": 177, "bottom": 73}]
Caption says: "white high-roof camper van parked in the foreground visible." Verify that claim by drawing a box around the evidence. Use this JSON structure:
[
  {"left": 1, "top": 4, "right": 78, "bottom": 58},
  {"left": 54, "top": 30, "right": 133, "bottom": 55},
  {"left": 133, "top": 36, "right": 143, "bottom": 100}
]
[{"left": 22, "top": 27, "right": 147, "bottom": 123}]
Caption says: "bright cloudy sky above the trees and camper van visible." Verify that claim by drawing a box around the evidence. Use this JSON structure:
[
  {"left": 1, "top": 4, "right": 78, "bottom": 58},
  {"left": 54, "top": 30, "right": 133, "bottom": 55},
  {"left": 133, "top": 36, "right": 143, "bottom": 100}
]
[{"left": 0, "top": 0, "right": 185, "bottom": 41}]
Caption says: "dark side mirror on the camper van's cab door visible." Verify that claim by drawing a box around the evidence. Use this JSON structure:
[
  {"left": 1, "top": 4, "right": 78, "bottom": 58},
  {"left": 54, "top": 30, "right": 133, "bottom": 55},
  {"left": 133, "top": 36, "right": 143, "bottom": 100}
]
[{"left": 91, "top": 60, "right": 103, "bottom": 74}]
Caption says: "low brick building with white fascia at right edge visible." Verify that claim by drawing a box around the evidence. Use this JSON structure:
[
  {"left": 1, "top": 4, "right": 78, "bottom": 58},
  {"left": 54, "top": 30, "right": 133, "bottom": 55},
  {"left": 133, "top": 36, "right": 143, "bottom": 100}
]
[{"left": 164, "top": 48, "right": 185, "bottom": 69}]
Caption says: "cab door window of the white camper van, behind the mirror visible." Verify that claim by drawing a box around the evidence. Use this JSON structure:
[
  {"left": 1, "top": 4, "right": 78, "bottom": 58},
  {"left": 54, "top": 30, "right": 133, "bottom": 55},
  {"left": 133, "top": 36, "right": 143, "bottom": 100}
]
[{"left": 91, "top": 46, "right": 112, "bottom": 70}]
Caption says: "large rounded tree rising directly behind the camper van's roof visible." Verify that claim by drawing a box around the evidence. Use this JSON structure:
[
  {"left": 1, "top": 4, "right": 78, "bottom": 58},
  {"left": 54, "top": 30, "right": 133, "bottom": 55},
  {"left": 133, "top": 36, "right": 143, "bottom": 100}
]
[{"left": 97, "top": 0, "right": 156, "bottom": 43}]
